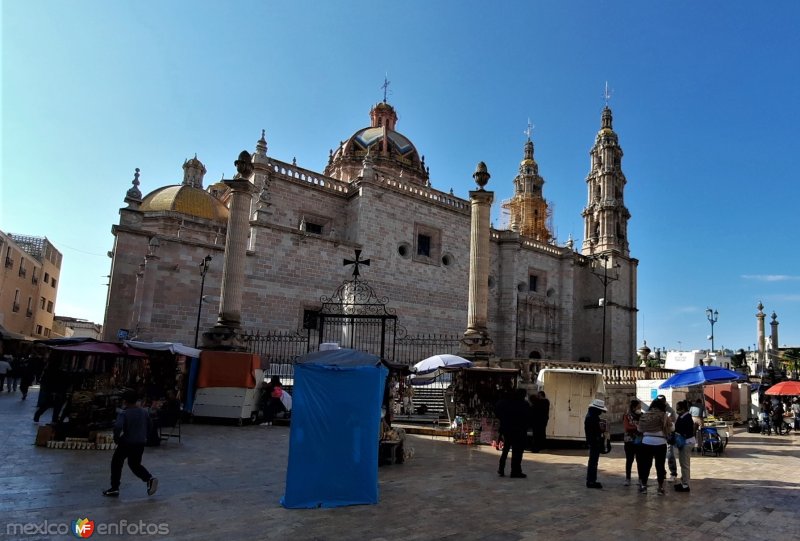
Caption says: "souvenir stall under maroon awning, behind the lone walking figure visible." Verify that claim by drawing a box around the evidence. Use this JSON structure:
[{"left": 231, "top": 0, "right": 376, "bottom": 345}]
[{"left": 37, "top": 341, "right": 151, "bottom": 442}]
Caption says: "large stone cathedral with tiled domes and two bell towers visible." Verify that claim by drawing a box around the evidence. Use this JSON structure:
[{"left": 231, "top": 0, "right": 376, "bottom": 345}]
[{"left": 103, "top": 99, "right": 638, "bottom": 365}]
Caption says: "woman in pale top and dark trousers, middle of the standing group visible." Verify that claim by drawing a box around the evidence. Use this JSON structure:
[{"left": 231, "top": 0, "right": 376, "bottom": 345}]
[{"left": 636, "top": 398, "right": 672, "bottom": 496}]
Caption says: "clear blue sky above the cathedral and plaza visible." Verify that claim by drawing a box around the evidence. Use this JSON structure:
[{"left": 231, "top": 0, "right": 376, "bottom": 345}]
[{"left": 0, "top": 0, "right": 800, "bottom": 349}]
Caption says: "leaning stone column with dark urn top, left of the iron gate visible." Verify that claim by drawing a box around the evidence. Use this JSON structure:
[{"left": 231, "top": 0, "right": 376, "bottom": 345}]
[{"left": 203, "top": 151, "right": 253, "bottom": 349}]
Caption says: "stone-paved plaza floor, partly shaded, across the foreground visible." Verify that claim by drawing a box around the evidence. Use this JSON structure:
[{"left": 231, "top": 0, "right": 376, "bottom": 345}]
[{"left": 0, "top": 390, "right": 800, "bottom": 541}]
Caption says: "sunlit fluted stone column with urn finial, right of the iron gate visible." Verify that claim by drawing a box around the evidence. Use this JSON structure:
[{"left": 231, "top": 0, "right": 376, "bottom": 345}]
[{"left": 461, "top": 162, "right": 494, "bottom": 360}]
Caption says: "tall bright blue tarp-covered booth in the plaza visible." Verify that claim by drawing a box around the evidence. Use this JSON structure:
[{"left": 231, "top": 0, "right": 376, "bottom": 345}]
[{"left": 281, "top": 349, "right": 389, "bottom": 509}]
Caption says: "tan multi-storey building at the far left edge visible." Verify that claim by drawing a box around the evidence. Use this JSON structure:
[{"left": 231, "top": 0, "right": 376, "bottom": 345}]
[{"left": 0, "top": 231, "right": 62, "bottom": 338}]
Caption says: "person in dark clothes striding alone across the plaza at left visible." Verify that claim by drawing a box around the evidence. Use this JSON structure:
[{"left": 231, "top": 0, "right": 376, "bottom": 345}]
[{"left": 103, "top": 391, "right": 158, "bottom": 497}]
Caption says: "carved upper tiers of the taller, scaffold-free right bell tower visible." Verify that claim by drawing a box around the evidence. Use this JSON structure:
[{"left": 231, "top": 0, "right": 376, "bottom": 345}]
[{"left": 582, "top": 97, "right": 631, "bottom": 257}]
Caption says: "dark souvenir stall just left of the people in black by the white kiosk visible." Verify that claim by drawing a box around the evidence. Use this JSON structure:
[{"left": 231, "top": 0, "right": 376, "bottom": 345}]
[{"left": 445, "top": 367, "right": 520, "bottom": 445}]
